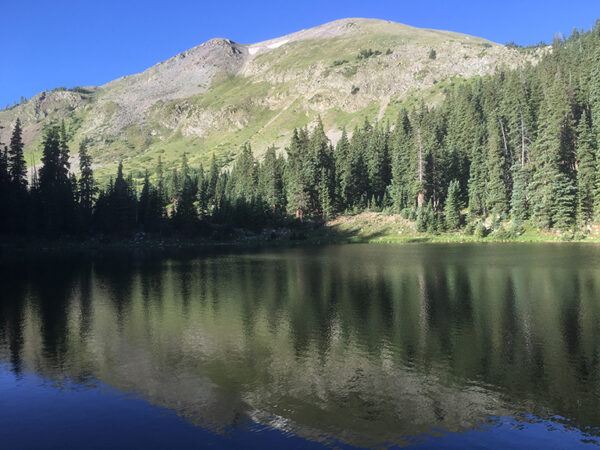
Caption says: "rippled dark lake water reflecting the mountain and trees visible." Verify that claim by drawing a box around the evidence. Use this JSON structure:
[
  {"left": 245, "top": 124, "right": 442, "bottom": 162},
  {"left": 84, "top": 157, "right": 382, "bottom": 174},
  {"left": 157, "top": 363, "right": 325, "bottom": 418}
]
[{"left": 0, "top": 244, "right": 600, "bottom": 449}]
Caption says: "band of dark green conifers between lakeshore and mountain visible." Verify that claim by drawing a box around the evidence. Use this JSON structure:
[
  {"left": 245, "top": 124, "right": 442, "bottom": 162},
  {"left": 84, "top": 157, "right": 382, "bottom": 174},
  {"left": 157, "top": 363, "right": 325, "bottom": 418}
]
[{"left": 0, "top": 24, "right": 600, "bottom": 236}]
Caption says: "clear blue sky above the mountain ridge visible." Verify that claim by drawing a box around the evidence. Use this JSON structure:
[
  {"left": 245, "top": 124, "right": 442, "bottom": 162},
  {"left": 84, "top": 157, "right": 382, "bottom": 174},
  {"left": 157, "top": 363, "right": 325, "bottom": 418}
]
[{"left": 0, "top": 0, "right": 600, "bottom": 107}]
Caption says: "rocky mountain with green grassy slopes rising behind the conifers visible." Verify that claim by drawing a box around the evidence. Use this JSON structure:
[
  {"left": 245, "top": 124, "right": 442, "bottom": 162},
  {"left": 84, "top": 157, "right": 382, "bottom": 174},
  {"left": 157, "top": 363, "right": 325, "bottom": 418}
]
[{"left": 0, "top": 19, "right": 542, "bottom": 176}]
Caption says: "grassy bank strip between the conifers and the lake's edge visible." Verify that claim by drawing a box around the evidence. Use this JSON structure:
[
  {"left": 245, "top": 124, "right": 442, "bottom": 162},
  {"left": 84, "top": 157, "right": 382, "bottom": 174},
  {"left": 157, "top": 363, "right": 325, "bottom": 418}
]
[{"left": 0, "top": 212, "right": 600, "bottom": 262}]
